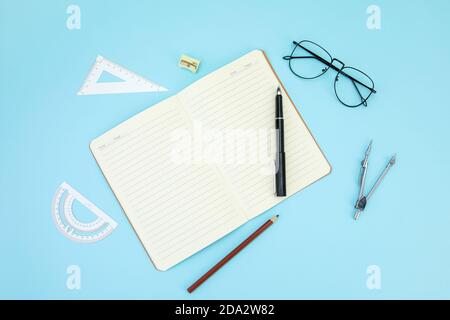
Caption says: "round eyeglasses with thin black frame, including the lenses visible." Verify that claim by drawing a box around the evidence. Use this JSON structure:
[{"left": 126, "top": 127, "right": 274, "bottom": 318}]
[{"left": 283, "top": 40, "right": 376, "bottom": 108}]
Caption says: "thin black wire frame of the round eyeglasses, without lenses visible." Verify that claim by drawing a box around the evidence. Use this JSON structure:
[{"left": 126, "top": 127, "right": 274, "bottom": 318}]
[{"left": 283, "top": 40, "right": 377, "bottom": 108}]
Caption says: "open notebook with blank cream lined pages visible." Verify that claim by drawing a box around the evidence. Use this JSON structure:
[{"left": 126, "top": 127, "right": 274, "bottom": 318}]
[{"left": 90, "top": 50, "right": 331, "bottom": 270}]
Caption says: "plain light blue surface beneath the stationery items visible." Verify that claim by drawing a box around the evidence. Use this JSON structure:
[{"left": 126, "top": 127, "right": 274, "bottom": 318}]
[{"left": 0, "top": 0, "right": 450, "bottom": 299}]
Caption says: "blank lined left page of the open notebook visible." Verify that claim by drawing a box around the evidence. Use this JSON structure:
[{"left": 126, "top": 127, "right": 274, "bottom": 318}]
[{"left": 91, "top": 96, "right": 245, "bottom": 270}]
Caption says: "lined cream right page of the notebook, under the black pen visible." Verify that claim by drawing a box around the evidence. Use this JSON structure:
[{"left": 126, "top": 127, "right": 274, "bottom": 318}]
[{"left": 179, "top": 50, "right": 330, "bottom": 219}]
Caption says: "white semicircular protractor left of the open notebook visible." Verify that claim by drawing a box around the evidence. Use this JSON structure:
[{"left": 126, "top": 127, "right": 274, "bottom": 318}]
[{"left": 52, "top": 182, "right": 117, "bottom": 243}]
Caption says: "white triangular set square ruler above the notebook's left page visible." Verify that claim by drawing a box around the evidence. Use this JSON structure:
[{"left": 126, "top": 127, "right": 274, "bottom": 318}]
[{"left": 78, "top": 56, "right": 167, "bottom": 95}]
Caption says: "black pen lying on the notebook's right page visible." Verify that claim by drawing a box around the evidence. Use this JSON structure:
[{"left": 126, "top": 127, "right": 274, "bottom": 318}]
[{"left": 275, "top": 87, "right": 286, "bottom": 197}]
